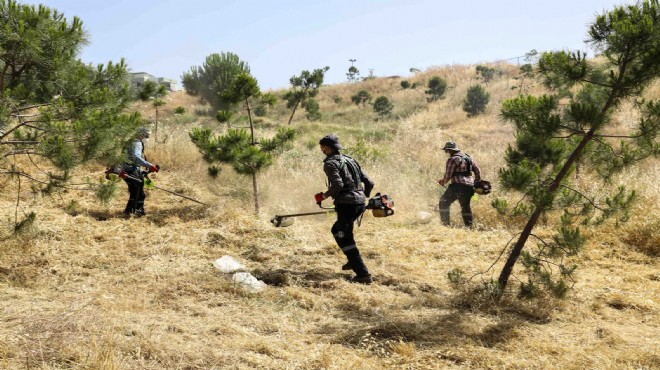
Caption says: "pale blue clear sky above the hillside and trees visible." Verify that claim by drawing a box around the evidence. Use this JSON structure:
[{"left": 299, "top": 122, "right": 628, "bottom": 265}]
[{"left": 38, "top": 0, "right": 625, "bottom": 90}]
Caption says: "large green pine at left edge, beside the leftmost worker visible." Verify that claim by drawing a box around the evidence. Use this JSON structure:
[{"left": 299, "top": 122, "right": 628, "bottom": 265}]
[{"left": 0, "top": 0, "right": 141, "bottom": 227}]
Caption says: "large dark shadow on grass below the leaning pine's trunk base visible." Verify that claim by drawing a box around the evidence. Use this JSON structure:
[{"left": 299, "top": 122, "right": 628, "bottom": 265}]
[{"left": 326, "top": 284, "right": 555, "bottom": 363}]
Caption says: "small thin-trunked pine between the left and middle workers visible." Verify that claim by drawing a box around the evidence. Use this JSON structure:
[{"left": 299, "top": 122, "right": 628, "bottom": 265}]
[{"left": 190, "top": 73, "right": 295, "bottom": 214}]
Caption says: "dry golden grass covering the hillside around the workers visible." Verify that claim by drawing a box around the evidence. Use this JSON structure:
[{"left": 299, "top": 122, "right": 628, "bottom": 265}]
[{"left": 0, "top": 64, "right": 660, "bottom": 369}]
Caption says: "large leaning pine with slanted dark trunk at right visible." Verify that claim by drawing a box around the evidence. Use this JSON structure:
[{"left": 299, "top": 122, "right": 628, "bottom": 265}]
[{"left": 494, "top": 0, "right": 660, "bottom": 296}]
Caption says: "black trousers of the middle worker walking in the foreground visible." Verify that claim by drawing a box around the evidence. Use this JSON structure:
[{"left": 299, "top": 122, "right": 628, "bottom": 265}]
[{"left": 331, "top": 204, "right": 369, "bottom": 276}]
